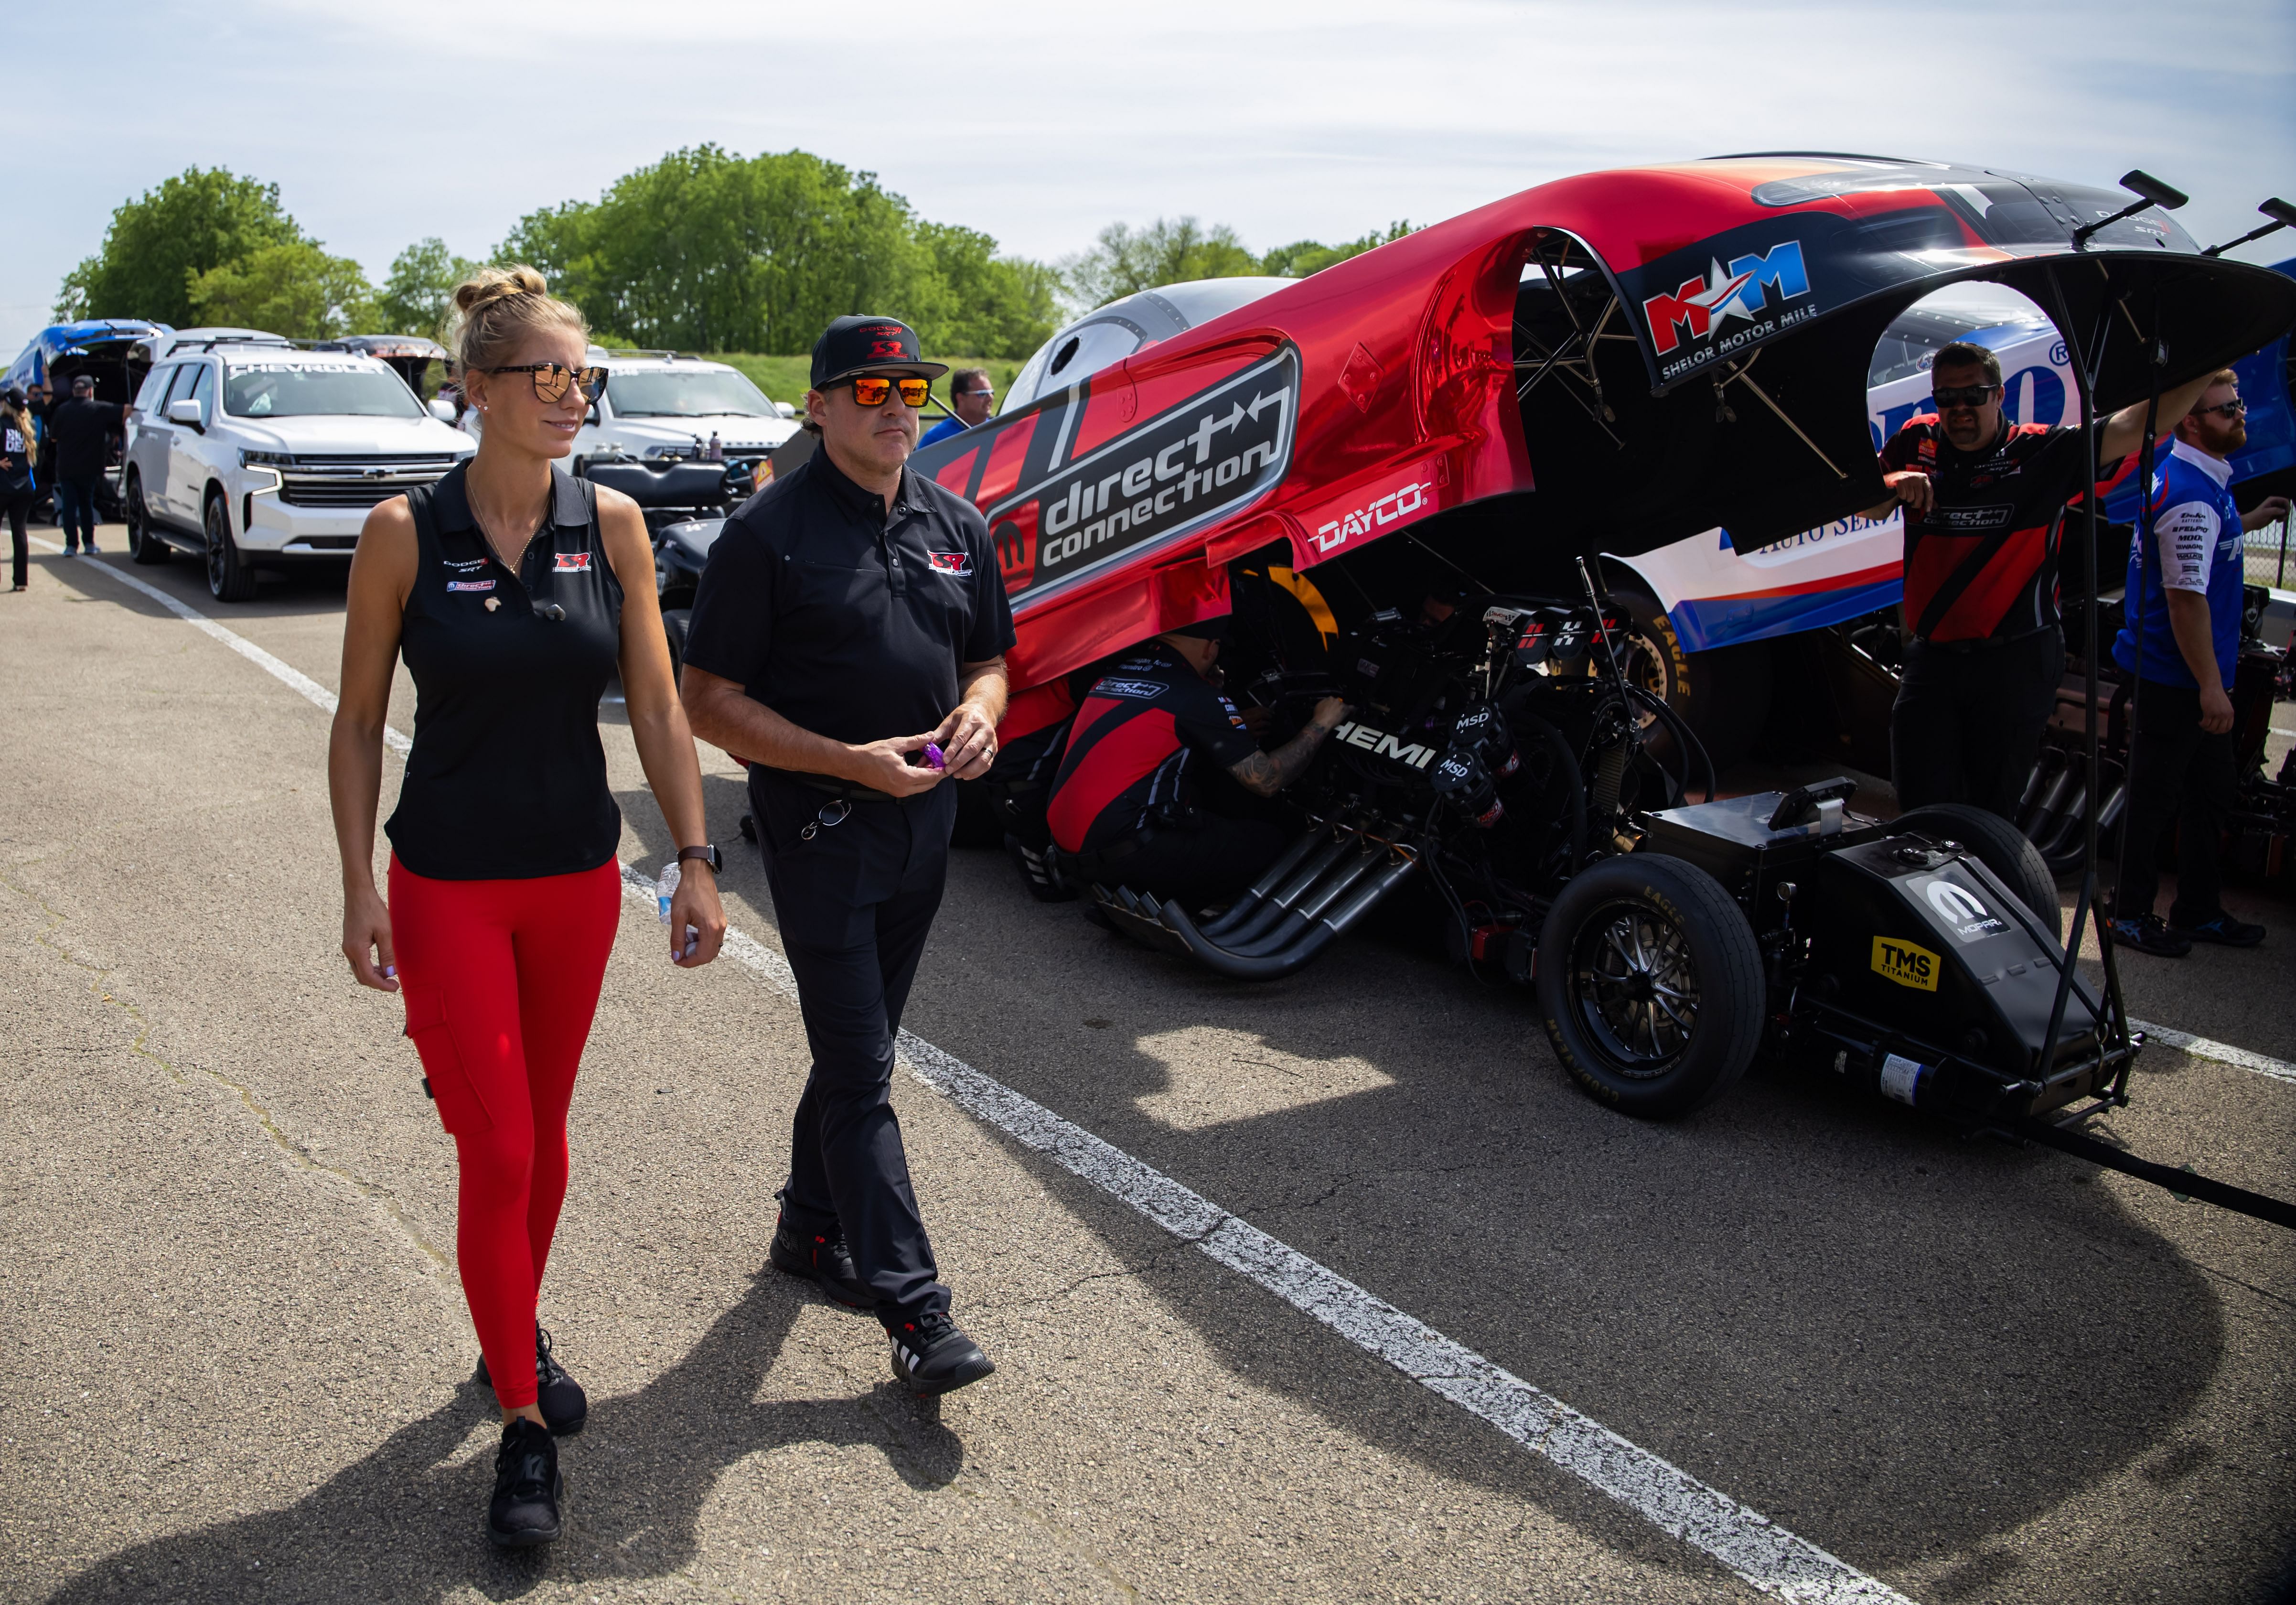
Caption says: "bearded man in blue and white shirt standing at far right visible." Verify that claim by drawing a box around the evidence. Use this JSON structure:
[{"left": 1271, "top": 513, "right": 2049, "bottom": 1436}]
[{"left": 2110, "top": 367, "right": 2289, "bottom": 958}]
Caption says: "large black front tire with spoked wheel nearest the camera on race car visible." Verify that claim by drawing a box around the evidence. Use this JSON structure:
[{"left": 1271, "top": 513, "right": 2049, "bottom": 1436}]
[{"left": 1538, "top": 852, "right": 1763, "bottom": 1120}]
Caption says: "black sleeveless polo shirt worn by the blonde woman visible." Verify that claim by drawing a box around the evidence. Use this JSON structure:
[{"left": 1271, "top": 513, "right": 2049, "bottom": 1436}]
[{"left": 384, "top": 466, "right": 622, "bottom": 879}]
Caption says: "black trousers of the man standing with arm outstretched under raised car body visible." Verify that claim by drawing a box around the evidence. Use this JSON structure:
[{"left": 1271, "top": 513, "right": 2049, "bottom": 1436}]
[{"left": 1889, "top": 627, "right": 2064, "bottom": 822}]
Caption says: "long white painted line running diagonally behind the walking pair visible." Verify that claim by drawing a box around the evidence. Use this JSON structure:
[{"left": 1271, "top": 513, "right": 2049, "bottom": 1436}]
[{"left": 58, "top": 542, "right": 1912, "bottom": 1605}]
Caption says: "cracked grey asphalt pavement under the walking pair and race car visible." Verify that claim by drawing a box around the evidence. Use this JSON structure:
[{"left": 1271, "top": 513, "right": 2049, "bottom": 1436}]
[{"left": 13, "top": 544, "right": 2296, "bottom": 1603}]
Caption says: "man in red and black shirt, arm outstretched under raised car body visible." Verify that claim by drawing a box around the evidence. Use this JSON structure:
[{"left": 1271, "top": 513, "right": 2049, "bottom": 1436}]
[{"left": 1867, "top": 340, "right": 2207, "bottom": 820}]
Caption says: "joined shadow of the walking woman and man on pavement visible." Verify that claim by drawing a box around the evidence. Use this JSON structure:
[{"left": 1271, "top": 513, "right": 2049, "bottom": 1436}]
[{"left": 48, "top": 1277, "right": 965, "bottom": 1605}]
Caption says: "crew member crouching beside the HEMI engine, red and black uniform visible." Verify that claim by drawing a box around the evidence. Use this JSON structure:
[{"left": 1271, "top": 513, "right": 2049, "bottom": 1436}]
[{"left": 1045, "top": 613, "right": 1348, "bottom": 909}]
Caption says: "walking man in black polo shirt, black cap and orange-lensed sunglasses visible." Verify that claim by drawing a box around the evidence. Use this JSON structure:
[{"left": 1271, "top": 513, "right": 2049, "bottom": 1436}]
[{"left": 684, "top": 317, "right": 1012, "bottom": 1394}]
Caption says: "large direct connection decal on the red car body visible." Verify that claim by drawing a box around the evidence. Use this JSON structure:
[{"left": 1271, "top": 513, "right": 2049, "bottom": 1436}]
[{"left": 987, "top": 347, "right": 1299, "bottom": 602}]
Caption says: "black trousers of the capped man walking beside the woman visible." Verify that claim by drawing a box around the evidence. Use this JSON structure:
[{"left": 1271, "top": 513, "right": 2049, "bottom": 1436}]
[{"left": 749, "top": 769, "right": 957, "bottom": 1323}]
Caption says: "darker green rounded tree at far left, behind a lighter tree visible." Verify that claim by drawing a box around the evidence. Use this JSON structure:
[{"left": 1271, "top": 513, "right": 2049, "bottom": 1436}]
[{"left": 55, "top": 168, "right": 303, "bottom": 328}]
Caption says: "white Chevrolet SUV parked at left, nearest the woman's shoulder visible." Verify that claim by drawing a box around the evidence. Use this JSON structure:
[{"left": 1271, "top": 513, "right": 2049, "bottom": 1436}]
[{"left": 119, "top": 328, "right": 475, "bottom": 602}]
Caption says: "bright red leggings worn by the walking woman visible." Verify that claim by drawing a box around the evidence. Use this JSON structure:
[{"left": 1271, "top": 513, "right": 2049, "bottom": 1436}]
[{"left": 390, "top": 854, "right": 622, "bottom": 1410}]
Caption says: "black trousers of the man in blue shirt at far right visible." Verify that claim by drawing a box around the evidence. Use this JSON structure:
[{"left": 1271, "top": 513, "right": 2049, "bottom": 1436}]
[{"left": 2113, "top": 679, "right": 2239, "bottom": 926}]
